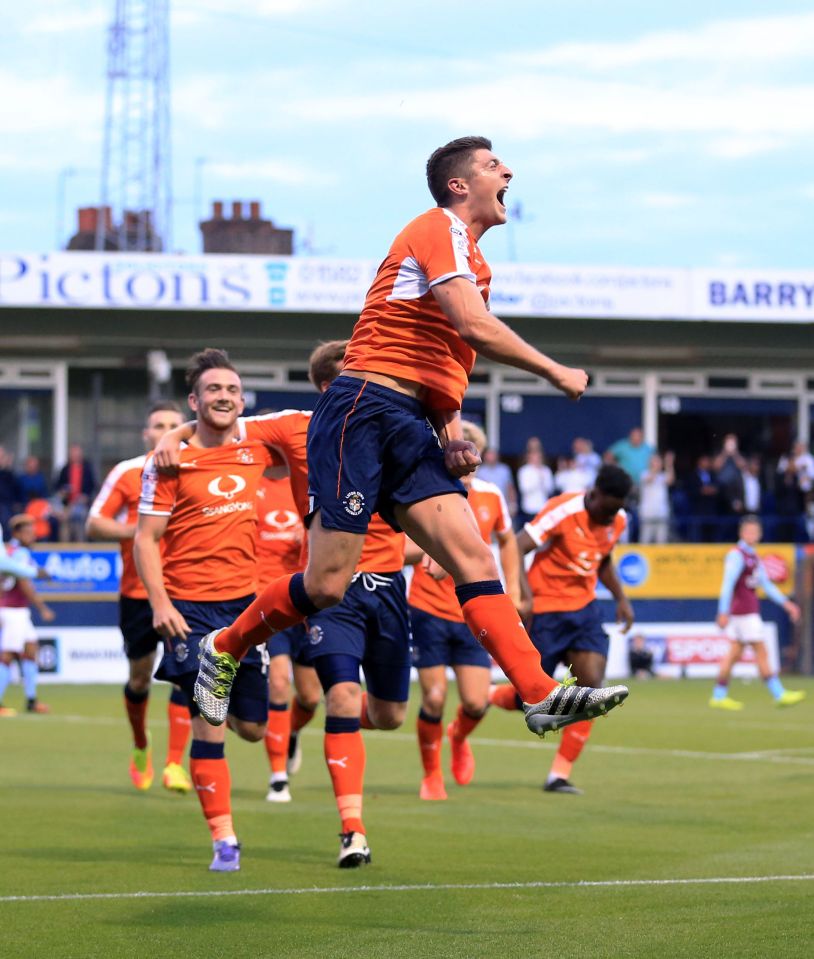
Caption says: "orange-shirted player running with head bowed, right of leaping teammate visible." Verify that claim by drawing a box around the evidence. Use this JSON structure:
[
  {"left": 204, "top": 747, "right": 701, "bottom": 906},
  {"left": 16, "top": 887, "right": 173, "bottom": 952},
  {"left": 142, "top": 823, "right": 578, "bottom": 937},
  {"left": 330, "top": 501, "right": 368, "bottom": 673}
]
[{"left": 490, "top": 465, "right": 633, "bottom": 794}]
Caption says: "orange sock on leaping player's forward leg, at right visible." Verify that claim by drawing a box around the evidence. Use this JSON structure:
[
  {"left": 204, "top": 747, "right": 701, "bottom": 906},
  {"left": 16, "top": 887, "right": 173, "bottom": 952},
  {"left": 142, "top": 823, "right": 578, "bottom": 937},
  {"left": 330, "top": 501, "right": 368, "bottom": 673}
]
[{"left": 458, "top": 587, "right": 559, "bottom": 703}]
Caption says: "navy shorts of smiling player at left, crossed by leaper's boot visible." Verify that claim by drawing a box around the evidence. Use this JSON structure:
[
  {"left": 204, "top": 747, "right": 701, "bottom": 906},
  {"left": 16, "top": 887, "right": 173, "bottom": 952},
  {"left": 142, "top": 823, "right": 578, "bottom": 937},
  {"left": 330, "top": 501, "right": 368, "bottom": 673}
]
[{"left": 155, "top": 595, "right": 269, "bottom": 723}]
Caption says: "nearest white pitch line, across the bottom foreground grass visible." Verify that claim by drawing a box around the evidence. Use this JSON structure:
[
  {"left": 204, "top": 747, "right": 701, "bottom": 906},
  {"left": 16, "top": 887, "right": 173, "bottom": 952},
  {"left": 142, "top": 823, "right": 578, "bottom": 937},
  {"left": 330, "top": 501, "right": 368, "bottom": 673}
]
[{"left": 0, "top": 873, "right": 814, "bottom": 903}]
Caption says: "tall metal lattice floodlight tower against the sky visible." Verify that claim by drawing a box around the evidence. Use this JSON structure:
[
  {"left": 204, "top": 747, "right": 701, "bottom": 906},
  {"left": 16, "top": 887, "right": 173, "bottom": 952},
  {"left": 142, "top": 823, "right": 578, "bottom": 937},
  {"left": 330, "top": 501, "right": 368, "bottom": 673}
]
[{"left": 96, "top": 0, "right": 172, "bottom": 251}]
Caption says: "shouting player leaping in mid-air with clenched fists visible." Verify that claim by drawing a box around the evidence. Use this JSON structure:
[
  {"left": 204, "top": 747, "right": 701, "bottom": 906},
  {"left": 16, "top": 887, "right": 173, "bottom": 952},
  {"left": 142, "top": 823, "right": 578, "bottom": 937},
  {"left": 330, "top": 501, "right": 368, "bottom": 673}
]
[{"left": 195, "top": 137, "right": 628, "bottom": 734}]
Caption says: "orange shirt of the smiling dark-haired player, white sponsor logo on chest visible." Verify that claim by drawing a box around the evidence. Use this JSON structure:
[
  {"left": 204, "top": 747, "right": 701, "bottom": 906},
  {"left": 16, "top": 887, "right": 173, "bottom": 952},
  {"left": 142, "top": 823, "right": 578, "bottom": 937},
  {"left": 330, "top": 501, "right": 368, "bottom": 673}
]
[{"left": 139, "top": 440, "right": 273, "bottom": 602}]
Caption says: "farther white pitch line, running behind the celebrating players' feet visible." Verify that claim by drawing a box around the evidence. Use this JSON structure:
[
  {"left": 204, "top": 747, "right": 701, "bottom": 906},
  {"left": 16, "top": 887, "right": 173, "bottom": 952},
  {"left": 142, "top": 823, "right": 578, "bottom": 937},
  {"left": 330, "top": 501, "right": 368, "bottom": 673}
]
[{"left": 15, "top": 713, "right": 814, "bottom": 766}]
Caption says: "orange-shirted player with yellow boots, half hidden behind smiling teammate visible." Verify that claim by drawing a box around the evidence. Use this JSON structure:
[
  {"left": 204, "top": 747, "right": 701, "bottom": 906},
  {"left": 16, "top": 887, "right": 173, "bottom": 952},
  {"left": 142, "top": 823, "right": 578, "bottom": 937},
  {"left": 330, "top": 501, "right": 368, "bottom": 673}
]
[{"left": 85, "top": 400, "right": 192, "bottom": 793}]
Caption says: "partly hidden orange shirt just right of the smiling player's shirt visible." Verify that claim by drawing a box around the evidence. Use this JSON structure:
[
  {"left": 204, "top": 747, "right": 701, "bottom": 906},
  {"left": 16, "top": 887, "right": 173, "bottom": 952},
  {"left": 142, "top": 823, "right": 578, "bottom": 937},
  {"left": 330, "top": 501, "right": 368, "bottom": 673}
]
[{"left": 257, "top": 476, "right": 305, "bottom": 589}]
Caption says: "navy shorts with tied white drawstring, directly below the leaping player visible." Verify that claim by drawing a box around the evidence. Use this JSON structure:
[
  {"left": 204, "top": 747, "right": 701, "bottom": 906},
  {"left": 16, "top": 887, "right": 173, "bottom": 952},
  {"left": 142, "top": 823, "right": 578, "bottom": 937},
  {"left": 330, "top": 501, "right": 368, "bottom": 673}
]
[{"left": 305, "top": 572, "right": 411, "bottom": 703}]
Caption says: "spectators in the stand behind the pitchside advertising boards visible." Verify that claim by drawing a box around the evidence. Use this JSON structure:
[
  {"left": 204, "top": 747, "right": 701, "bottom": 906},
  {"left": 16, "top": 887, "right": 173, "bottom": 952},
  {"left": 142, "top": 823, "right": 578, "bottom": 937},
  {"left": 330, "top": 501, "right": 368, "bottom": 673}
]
[{"left": 0, "top": 426, "right": 814, "bottom": 543}]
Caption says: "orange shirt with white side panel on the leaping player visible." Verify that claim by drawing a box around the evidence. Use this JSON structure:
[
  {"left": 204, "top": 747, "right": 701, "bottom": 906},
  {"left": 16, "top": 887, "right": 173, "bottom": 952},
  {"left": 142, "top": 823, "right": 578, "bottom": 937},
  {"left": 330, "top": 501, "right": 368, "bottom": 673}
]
[{"left": 343, "top": 207, "right": 492, "bottom": 409}]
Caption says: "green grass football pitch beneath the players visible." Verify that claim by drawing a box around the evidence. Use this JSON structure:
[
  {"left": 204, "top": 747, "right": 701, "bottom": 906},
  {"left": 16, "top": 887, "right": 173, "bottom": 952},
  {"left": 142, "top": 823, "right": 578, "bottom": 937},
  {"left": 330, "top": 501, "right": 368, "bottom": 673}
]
[{"left": 0, "top": 679, "right": 814, "bottom": 959}]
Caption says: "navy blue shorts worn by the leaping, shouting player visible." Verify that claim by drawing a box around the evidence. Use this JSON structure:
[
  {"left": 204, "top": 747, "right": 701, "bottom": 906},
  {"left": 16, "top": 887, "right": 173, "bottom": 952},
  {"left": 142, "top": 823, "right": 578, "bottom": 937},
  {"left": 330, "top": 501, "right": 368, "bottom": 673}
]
[{"left": 306, "top": 376, "right": 466, "bottom": 533}]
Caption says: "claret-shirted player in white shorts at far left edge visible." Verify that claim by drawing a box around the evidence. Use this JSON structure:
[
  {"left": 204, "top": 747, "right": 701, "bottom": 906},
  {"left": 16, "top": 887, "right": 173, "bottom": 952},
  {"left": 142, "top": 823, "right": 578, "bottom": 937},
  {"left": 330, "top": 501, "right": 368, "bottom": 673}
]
[{"left": 0, "top": 513, "right": 54, "bottom": 716}]
